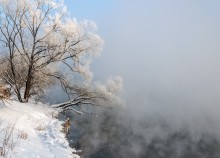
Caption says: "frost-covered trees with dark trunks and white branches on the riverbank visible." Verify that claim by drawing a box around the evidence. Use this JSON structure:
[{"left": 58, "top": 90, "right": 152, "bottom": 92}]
[{"left": 0, "top": 0, "right": 122, "bottom": 109}]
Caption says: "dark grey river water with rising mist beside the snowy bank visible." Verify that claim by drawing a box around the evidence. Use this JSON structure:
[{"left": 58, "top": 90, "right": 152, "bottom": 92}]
[{"left": 58, "top": 110, "right": 220, "bottom": 158}]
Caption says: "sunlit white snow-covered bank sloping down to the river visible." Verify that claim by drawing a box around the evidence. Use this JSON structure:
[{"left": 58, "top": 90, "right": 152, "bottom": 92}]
[{"left": 0, "top": 101, "right": 79, "bottom": 158}]
